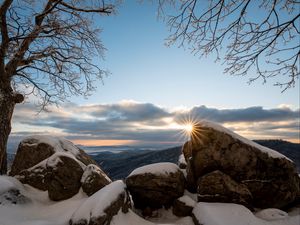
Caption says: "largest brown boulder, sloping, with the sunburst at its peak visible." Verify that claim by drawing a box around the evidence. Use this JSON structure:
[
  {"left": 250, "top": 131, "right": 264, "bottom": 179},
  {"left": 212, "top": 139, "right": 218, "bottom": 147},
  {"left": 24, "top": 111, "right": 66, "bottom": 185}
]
[{"left": 183, "top": 121, "right": 300, "bottom": 208}]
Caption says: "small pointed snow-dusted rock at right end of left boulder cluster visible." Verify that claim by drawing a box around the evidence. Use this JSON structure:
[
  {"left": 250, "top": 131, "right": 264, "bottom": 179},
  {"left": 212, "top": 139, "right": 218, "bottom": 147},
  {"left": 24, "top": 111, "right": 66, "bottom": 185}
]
[{"left": 81, "top": 164, "right": 111, "bottom": 196}]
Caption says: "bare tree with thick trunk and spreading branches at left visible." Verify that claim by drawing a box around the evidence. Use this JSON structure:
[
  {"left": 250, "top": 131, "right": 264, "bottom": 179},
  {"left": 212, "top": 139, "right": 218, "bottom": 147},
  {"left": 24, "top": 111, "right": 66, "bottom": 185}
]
[{"left": 0, "top": 0, "right": 115, "bottom": 174}]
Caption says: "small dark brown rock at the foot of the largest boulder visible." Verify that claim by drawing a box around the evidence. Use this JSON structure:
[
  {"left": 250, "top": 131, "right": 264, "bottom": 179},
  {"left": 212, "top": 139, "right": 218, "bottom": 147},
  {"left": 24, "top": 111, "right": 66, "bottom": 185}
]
[{"left": 197, "top": 170, "right": 252, "bottom": 207}]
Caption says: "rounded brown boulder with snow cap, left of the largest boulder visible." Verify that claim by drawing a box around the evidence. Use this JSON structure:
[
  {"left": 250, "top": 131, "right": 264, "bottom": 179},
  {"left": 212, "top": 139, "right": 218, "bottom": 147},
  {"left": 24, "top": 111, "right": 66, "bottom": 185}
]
[{"left": 126, "top": 163, "right": 185, "bottom": 209}]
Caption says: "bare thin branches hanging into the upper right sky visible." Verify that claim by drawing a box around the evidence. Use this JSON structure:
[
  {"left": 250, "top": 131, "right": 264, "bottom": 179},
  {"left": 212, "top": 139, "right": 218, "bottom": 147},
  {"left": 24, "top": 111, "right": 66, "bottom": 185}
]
[{"left": 159, "top": 0, "right": 300, "bottom": 91}]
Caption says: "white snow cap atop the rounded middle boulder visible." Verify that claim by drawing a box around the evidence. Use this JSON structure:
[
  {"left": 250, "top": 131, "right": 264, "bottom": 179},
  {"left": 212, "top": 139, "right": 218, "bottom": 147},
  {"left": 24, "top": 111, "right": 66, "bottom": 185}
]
[{"left": 128, "top": 162, "right": 180, "bottom": 177}]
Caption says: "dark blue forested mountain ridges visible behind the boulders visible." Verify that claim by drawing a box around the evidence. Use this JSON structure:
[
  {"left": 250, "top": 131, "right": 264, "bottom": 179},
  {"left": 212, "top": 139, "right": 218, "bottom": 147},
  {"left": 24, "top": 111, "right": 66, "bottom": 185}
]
[{"left": 8, "top": 140, "right": 300, "bottom": 180}]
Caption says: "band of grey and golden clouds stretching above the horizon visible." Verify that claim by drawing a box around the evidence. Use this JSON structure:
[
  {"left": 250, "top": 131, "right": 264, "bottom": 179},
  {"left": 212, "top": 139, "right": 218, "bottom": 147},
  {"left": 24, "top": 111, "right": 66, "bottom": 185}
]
[{"left": 11, "top": 101, "right": 300, "bottom": 148}]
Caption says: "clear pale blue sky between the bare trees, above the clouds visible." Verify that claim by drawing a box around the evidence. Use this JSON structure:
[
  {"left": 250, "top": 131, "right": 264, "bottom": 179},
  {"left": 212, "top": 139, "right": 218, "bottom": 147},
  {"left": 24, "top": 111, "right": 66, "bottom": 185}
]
[{"left": 69, "top": 1, "right": 299, "bottom": 108}]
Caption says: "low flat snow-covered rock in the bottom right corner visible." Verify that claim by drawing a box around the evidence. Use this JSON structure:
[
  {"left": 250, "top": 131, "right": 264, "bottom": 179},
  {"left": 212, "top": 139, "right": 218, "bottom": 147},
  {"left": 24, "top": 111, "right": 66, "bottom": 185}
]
[{"left": 193, "top": 202, "right": 300, "bottom": 225}]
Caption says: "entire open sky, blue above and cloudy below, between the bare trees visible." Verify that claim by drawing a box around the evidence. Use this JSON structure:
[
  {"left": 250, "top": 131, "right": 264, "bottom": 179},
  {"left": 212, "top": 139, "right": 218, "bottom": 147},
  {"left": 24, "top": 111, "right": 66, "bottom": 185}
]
[{"left": 10, "top": 1, "right": 300, "bottom": 149}]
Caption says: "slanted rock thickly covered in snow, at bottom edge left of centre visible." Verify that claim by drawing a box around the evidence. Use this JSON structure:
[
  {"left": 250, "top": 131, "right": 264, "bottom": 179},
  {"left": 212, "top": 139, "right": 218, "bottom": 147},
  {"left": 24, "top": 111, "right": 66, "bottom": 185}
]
[{"left": 69, "top": 180, "right": 130, "bottom": 225}]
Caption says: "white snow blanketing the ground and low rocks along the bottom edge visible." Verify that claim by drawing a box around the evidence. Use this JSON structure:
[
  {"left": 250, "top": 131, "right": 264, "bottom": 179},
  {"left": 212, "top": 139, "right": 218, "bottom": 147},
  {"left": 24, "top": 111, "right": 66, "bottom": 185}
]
[{"left": 0, "top": 176, "right": 300, "bottom": 225}]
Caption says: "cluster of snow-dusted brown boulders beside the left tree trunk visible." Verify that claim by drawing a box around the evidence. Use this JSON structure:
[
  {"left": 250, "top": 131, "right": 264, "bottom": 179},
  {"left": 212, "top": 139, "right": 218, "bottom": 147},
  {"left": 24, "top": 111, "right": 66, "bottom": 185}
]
[{"left": 11, "top": 136, "right": 110, "bottom": 201}]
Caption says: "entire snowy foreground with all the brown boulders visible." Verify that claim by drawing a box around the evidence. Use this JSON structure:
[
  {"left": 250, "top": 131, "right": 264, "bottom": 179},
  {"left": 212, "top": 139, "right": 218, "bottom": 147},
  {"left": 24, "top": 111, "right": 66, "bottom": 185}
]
[{"left": 0, "top": 122, "right": 300, "bottom": 225}]
